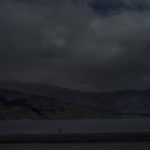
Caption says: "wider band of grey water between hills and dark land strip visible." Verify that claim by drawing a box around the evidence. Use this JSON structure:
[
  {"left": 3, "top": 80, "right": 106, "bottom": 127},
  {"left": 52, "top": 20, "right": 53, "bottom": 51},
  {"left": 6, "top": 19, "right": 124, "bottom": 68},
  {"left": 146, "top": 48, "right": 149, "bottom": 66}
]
[{"left": 0, "top": 118, "right": 150, "bottom": 134}]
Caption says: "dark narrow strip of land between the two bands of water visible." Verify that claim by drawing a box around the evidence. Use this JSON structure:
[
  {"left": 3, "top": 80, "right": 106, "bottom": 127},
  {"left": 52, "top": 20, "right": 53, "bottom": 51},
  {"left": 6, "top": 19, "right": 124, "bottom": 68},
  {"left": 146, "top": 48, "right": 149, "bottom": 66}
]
[{"left": 0, "top": 132, "right": 150, "bottom": 143}]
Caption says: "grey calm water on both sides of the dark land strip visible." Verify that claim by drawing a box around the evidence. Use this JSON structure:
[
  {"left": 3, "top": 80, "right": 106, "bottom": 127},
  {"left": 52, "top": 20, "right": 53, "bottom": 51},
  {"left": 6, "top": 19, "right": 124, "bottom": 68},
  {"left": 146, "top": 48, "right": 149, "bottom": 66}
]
[{"left": 0, "top": 118, "right": 150, "bottom": 150}]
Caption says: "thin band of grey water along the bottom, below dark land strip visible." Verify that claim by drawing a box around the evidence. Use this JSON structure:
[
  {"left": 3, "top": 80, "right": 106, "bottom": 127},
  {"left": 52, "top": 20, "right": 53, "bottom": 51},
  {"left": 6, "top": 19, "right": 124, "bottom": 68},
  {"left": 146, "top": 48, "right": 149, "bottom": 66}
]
[{"left": 0, "top": 142, "right": 150, "bottom": 150}]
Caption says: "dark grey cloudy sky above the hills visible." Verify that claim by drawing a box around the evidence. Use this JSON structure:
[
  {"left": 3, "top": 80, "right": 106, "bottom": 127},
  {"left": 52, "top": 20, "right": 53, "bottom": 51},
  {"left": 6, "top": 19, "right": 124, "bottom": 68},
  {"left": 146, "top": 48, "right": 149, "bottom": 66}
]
[{"left": 0, "top": 0, "right": 150, "bottom": 91}]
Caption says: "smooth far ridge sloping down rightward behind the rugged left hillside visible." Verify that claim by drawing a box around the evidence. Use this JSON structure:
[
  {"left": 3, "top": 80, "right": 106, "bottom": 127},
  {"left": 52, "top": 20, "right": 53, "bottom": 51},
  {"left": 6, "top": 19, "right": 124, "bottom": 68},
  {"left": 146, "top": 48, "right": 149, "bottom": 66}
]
[{"left": 0, "top": 82, "right": 102, "bottom": 105}]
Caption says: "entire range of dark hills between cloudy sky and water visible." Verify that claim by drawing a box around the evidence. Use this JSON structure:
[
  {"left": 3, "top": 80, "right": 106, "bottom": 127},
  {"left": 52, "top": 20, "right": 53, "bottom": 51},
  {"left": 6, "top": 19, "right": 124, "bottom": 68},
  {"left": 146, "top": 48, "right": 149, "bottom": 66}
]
[{"left": 0, "top": 82, "right": 150, "bottom": 119}]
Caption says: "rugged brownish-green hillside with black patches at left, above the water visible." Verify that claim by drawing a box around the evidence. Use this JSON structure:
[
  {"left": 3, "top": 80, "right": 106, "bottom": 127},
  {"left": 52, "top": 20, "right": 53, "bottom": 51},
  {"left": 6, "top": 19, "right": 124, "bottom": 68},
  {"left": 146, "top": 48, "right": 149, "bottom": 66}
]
[{"left": 0, "top": 89, "right": 103, "bottom": 120}]
